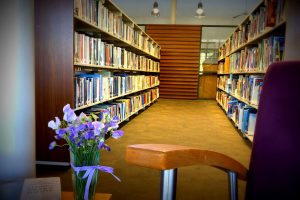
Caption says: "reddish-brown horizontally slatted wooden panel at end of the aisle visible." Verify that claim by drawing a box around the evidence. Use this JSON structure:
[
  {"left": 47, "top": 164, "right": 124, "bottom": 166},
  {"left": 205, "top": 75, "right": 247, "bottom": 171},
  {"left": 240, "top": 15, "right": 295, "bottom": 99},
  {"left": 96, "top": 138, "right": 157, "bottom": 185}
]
[{"left": 146, "top": 25, "right": 201, "bottom": 99}]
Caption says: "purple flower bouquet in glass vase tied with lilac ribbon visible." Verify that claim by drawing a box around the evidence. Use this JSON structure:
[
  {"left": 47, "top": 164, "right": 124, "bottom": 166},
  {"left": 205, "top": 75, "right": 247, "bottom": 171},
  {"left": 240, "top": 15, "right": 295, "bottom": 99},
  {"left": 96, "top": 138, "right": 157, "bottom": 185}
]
[{"left": 48, "top": 104, "right": 124, "bottom": 200}]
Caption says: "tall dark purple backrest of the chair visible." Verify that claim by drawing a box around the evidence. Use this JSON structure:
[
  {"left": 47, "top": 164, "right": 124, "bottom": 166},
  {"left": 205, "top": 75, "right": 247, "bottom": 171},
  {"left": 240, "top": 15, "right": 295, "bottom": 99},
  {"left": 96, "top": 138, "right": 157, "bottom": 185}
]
[{"left": 246, "top": 61, "right": 300, "bottom": 200}]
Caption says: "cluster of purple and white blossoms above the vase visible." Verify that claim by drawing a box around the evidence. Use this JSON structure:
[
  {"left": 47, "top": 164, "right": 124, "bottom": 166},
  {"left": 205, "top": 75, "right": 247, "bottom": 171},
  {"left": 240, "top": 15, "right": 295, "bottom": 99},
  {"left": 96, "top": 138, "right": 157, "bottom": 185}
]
[{"left": 48, "top": 104, "right": 124, "bottom": 151}]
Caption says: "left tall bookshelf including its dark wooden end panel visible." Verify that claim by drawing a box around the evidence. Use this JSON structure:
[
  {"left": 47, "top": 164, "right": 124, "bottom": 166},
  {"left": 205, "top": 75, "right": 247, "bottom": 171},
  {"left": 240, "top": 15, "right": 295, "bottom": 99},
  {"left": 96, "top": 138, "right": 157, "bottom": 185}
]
[{"left": 35, "top": 0, "right": 160, "bottom": 165}]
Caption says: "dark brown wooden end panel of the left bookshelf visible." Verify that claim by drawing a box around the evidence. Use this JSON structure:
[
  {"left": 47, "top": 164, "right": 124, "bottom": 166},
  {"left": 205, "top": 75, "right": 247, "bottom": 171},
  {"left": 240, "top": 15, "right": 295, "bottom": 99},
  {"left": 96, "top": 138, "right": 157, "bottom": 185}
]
[{"left": 35, "top": 0, "right": 74, "bottom": 162}]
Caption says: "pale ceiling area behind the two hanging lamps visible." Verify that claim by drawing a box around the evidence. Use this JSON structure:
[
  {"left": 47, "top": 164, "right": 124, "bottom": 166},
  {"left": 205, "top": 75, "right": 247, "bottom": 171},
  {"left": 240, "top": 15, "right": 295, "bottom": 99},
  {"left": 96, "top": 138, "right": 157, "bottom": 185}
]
[{"left": 112, "top": 0, "right": 261, "bottom": 25}]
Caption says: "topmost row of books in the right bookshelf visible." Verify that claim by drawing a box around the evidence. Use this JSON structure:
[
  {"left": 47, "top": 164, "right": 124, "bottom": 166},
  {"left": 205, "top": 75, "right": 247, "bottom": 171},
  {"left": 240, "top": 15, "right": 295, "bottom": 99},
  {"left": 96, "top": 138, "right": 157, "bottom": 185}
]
[{"left": 219, "top": 0, "right": 286, "bottom": 57}]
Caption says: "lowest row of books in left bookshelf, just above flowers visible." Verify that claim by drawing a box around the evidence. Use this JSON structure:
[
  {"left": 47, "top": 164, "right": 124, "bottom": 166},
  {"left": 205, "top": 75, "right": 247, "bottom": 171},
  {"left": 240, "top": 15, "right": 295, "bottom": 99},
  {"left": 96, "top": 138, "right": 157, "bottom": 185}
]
[{"left": 85, "top": 88, "right": 159, "bottom": 122}]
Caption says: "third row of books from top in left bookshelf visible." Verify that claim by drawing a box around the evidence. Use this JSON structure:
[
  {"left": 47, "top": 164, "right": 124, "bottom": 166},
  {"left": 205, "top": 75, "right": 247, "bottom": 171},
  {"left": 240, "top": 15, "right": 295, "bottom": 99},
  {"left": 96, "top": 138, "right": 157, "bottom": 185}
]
[{"left": 74, "top": 72, "right": 159, "bottom": 108}]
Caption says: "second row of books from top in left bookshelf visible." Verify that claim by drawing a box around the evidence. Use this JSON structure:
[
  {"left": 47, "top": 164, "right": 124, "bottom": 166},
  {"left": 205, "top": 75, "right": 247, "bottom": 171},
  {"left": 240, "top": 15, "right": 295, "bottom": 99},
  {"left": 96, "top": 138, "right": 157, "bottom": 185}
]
[{"left": 74, "top": 31, "right": 160, "bottom": 72}]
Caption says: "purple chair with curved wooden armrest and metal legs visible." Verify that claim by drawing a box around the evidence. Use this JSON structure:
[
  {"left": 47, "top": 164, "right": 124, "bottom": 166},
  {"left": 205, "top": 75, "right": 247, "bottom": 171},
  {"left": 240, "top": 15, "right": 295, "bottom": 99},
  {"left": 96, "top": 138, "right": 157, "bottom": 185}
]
[{"left": 126, "top": 61, "right": 300, "bottom": 200}]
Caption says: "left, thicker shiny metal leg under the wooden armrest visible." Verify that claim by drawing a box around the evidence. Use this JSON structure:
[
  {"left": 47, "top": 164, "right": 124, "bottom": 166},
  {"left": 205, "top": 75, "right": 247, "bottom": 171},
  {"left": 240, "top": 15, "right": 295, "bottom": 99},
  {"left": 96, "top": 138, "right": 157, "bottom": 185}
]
[{"left": 160, "top": 169, "right": 177, "bottom": 200}]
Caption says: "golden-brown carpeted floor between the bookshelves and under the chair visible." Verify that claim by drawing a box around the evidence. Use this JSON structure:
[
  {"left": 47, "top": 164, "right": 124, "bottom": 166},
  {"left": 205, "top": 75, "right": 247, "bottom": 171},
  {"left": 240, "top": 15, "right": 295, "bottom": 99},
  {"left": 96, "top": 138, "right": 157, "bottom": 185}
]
[{"left": 37, "top": 99, "right": 251, "bottom": 200}]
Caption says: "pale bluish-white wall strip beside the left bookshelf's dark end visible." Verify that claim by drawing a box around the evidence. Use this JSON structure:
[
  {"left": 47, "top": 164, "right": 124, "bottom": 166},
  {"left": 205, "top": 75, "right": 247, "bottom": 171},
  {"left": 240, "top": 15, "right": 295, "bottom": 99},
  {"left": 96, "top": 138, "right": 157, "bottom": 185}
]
[{"left": 0, "top": 0, "right": 35, "bottom": 199}]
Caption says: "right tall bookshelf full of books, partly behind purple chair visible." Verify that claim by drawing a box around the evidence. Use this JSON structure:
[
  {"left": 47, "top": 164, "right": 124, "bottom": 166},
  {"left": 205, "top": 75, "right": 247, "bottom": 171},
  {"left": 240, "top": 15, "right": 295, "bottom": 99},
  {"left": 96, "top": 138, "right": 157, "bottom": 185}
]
[{"left": 216, "top": 0, "right": 286, "bottom": 142}]
